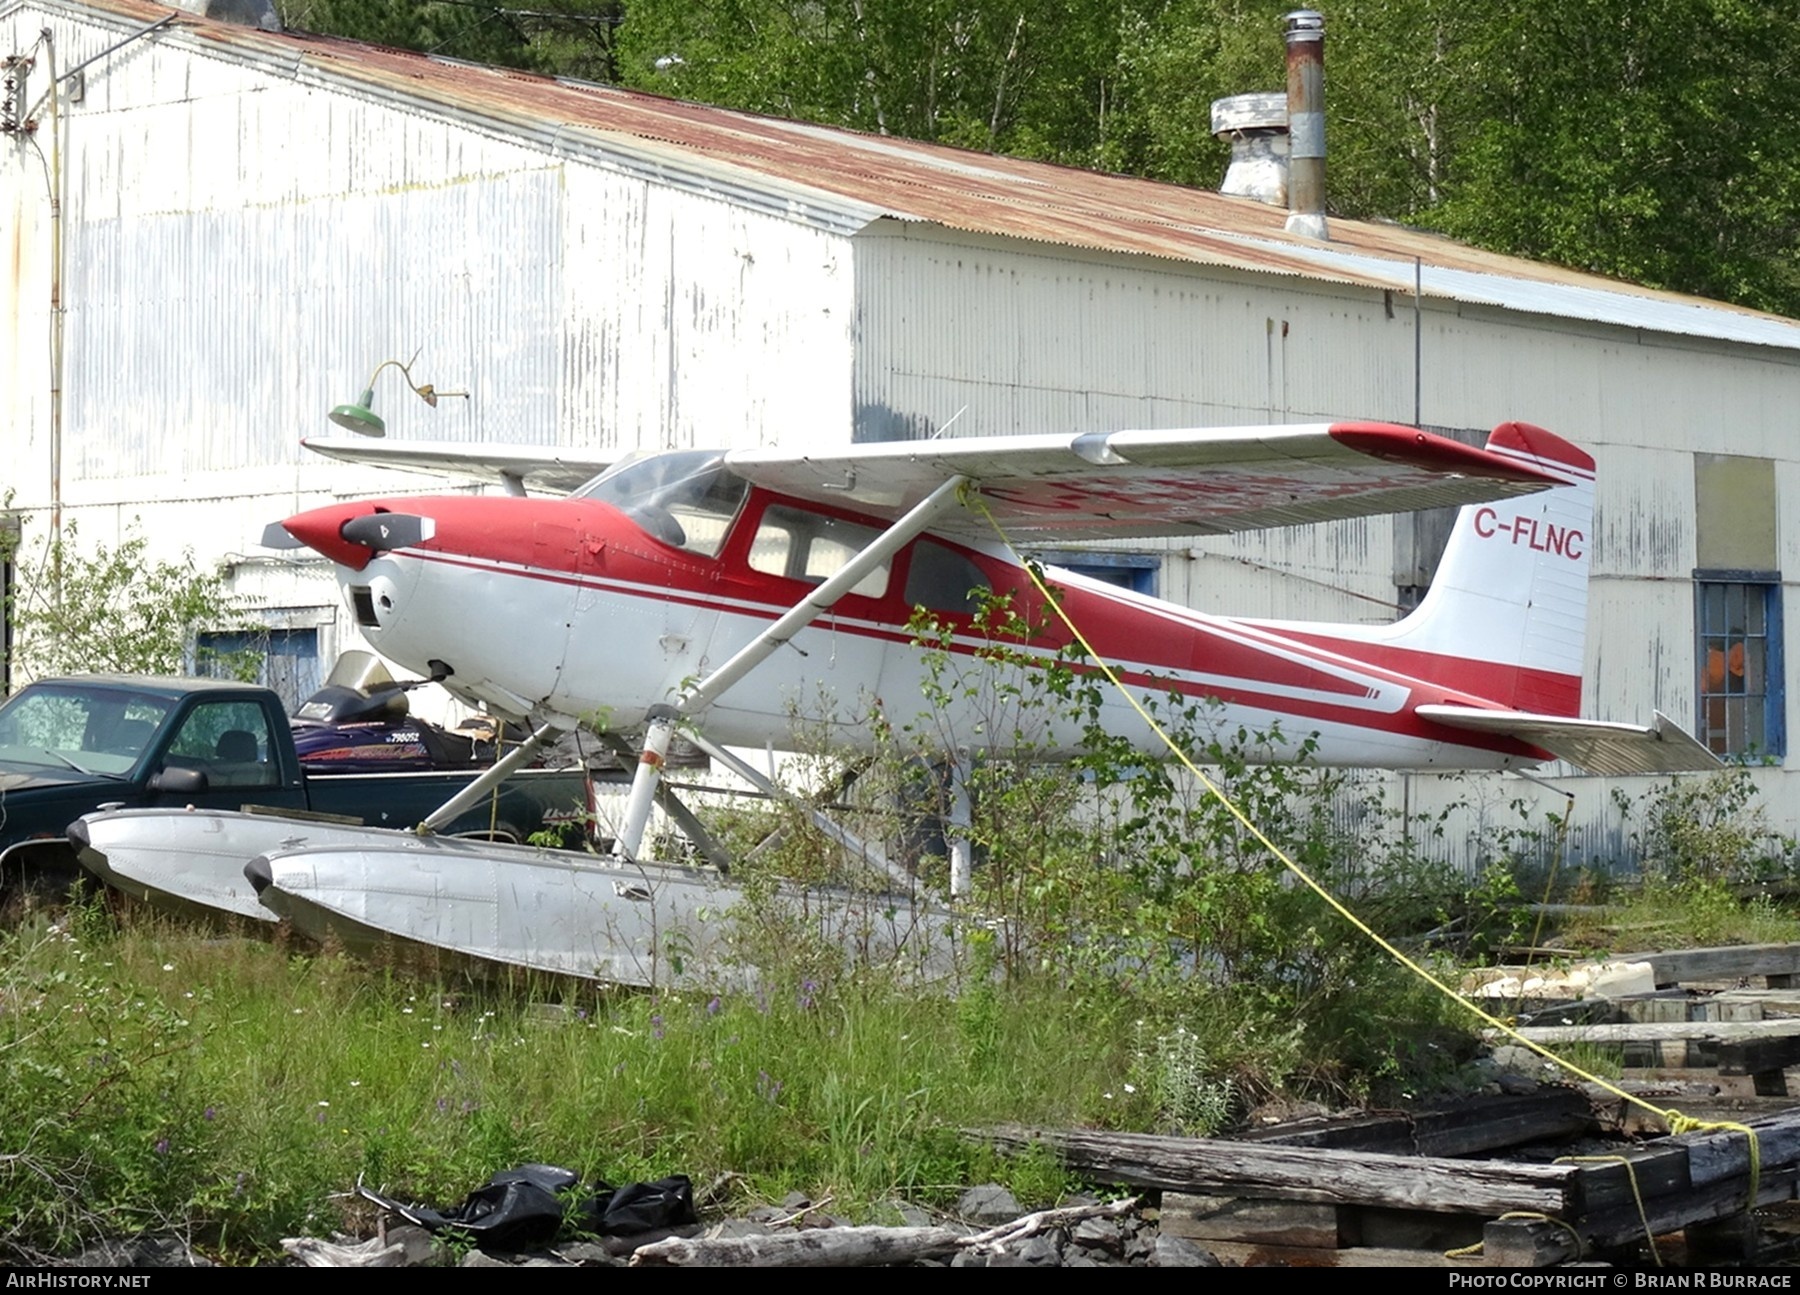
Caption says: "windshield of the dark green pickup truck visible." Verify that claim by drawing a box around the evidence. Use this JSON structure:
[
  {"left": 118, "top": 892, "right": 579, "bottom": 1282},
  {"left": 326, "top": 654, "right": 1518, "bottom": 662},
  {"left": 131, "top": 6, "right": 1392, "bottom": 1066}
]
[{"left": 0, "top": 684, "right": 171, "bottom": 776}]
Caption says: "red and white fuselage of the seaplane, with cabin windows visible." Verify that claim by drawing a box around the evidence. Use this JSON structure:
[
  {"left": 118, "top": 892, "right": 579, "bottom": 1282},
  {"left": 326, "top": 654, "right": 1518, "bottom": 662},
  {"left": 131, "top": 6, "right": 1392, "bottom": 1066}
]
[{"left": 273, "top": 455, "right": 1555, "bottom": 769}]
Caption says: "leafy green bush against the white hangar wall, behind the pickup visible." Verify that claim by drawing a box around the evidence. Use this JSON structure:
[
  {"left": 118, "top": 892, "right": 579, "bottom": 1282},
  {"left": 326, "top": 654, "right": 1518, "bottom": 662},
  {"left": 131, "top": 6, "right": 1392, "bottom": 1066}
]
[{"left": 11, "top": 522, "right": 256, "bottom": 677}]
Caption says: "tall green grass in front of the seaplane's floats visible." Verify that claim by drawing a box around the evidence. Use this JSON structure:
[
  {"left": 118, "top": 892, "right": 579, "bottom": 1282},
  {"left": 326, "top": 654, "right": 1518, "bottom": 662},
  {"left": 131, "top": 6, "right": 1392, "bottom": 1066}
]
[{"left": 0, "top": 906, "right": 1130, "bottom": 1255}]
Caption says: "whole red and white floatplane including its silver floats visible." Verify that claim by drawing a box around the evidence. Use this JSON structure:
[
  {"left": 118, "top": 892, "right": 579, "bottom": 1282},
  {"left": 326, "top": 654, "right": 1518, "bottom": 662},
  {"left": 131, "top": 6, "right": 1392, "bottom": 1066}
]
[{"left": 70, "top": 423, "right": 1715, "bottom": 983}]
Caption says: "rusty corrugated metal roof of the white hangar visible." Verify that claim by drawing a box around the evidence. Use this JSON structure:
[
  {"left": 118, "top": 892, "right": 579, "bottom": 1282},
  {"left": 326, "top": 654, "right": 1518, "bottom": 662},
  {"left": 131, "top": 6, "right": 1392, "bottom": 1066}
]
[{"left": 45, "top": 0, "right": 1800, "bottom": 349}]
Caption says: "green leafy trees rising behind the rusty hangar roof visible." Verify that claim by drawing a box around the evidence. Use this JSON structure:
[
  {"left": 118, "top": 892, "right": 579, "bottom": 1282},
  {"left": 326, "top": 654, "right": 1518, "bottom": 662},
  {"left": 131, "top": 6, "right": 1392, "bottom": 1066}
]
[{"left": 281, "top": 0, "right": 1800, "bottom": 315}]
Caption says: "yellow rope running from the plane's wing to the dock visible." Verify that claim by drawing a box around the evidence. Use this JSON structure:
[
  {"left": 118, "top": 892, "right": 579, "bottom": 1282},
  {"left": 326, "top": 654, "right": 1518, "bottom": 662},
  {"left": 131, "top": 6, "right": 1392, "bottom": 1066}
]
[{"left": 970, "top": 494, "right": 1762, "bottom": 1209}]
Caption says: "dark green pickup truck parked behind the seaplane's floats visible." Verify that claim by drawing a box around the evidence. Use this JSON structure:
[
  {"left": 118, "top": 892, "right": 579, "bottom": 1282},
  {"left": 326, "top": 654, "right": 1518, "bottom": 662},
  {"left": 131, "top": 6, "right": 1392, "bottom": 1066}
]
[{"left": 0, "top": 675, "right": 592, "bottom": 888}]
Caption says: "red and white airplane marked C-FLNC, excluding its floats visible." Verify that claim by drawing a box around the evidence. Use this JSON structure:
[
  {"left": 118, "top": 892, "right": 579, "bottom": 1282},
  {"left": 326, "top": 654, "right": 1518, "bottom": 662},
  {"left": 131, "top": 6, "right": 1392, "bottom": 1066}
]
[{"left": 277, "top": 421, "right": 1717, "bottom": 859}]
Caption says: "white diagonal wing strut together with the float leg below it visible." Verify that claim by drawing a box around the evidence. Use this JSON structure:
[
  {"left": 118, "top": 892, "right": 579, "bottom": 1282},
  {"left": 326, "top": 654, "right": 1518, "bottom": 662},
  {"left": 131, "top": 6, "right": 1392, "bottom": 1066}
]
[{"left": 614, "top": 475, "right": 968, "bottom": 861}]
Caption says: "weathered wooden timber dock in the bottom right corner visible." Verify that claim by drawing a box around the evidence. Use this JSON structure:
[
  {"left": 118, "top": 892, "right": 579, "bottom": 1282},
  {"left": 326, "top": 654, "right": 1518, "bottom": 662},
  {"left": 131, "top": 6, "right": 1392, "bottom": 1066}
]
[{"left": 979, "top": 1088, "right": 1800, "bottom": 1268}]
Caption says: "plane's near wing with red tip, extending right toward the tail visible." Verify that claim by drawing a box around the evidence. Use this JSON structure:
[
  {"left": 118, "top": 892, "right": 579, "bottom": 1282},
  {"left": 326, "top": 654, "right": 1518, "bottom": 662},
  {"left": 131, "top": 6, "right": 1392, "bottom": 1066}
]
[{"left": 725, "top": 423, "right": 1566, "bottom": 542}]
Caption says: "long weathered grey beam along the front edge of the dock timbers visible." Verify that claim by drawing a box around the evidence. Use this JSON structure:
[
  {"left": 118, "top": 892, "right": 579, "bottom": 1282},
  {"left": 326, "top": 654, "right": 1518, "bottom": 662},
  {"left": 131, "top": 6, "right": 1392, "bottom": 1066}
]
[{"left": 967, "top": 1127, "right": 1575, "bottom": 1218}]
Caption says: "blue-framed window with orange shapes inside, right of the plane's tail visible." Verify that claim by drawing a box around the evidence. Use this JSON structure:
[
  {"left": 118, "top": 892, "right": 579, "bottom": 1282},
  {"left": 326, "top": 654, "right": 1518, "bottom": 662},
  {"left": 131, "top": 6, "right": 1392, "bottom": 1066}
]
[{"left": 1694, "top": 571, "right": 1787, "bottom": 758}]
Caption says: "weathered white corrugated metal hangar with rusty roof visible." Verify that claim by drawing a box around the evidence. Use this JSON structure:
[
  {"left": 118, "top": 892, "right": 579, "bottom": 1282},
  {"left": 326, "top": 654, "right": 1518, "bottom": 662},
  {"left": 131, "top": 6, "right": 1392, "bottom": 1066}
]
[{"left": 0, "top": 0, "right": 1800, "bottom": 871}]
